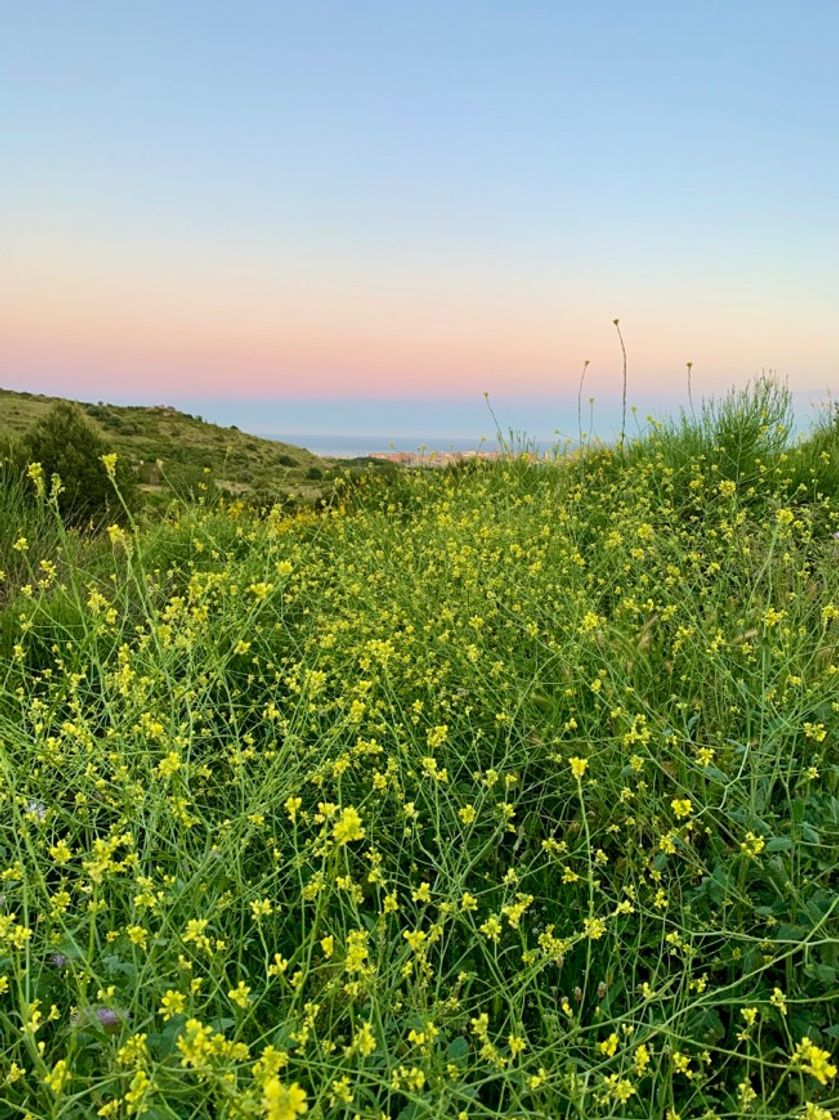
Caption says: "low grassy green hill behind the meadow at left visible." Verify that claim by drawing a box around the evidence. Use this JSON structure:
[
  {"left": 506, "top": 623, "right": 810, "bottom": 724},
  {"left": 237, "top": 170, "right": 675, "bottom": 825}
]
[{"left": 0, "top": 389, "right": 365, "bottom": 502}]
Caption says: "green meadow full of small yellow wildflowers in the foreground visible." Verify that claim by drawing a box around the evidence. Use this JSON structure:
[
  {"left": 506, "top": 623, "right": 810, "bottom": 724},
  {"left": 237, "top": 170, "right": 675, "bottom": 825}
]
[{"left": 0, "top": 383, "right": 839, "bottom": 1120}]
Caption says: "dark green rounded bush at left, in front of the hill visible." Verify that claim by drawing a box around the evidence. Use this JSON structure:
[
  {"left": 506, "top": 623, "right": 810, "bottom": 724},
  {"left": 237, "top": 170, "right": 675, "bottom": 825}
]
[{"left": 18, "top": 401, "right": 134, "bottom": 525}]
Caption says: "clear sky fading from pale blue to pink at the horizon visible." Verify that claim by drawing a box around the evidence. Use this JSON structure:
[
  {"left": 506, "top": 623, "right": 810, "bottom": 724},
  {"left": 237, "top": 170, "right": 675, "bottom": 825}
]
[{"left": 0, "top": 0, "right": 839, "bottom": 436}]
